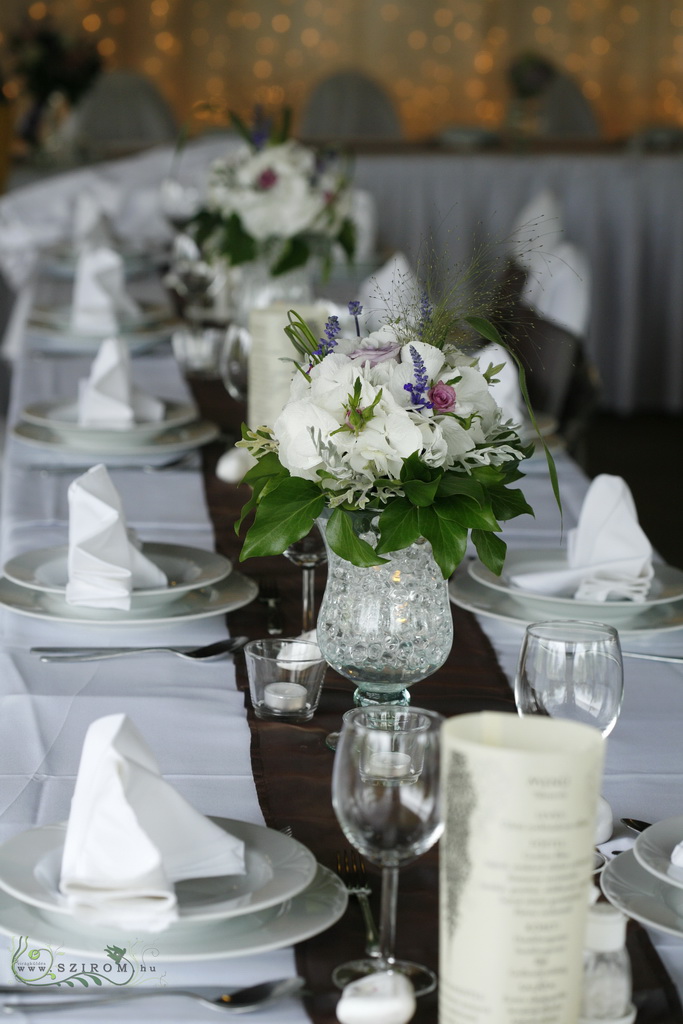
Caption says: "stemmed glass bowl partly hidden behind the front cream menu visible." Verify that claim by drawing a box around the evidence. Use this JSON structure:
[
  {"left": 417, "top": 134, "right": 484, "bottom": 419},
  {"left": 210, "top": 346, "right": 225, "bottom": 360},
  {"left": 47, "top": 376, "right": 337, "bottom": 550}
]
[{"left": 515, "top": 620, "right": 624, "bottom": 736}]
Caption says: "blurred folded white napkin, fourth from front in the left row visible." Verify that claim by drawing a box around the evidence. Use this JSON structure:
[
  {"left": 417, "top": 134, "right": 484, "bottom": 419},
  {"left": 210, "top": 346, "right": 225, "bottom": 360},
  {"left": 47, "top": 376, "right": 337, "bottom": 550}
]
[{"left": 71, "top": 246, "right": 140, "bottom": 334}]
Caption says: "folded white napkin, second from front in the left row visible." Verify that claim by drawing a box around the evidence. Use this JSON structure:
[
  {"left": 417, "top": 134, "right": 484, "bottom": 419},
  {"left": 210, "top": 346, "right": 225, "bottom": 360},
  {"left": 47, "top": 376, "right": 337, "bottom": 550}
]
[{"left": 67, "top": 465, "right": 168, "bottom": 610}]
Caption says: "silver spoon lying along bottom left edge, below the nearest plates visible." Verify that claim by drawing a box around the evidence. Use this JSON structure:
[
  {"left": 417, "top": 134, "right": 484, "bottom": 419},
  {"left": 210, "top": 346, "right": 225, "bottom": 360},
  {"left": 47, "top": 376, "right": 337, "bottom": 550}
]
[{"left": 0, "top": 978, "right": 304, "bottom": 1014}]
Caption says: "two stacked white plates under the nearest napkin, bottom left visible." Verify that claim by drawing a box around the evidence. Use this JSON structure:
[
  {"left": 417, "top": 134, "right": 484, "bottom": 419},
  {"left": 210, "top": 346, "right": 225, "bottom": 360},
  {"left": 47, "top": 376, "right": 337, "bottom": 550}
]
[{"left": 0, "top": 818, "right": 347, "bottom": 961}]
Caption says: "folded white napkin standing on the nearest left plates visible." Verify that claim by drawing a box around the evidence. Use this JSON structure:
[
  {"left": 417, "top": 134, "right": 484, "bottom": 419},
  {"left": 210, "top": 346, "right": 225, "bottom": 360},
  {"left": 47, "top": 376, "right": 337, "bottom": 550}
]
[{"left": 59, "top": 715, "right": 245, "bottom": 932}]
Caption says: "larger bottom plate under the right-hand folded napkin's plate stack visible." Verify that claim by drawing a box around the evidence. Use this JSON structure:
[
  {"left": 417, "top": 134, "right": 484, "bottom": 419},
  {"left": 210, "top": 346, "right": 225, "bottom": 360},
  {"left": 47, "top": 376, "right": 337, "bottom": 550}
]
[{"left": 449, "top": 566, "right": 683, "bottom": 636}]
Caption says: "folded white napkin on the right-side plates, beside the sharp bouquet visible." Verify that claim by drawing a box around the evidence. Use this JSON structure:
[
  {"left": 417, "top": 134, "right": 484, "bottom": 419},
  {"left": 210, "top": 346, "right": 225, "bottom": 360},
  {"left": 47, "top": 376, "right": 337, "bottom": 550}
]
[{"left": 511, "top": 473, "right": 654, "bottom": 602}]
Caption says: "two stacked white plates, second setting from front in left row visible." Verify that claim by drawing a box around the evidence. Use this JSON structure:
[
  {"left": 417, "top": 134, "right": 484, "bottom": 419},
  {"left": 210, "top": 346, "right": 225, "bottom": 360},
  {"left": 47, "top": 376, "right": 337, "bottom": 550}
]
[{"left": 0, "top": 543, "right": 258, "bottom": 626}]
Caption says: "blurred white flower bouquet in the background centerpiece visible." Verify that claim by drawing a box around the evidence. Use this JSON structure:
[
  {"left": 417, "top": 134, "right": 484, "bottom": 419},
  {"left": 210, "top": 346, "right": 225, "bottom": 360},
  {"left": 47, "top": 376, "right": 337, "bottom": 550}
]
[{"left": 190, "top": 112, "right": 354, "bottom": 276}]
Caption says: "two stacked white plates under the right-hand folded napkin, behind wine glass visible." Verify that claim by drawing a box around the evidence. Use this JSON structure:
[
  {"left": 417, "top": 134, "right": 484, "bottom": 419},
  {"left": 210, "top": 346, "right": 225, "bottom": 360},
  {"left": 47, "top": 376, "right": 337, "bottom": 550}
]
[{"left": 449, "top": 549, "right": 683, "bottom": 634}]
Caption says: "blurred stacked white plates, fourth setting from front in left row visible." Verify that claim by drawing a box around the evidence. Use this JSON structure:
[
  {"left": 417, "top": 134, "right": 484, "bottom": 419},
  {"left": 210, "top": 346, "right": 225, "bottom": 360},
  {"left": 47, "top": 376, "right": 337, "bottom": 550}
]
[{"left": 27, "top": 303, "right": 176, "bottom": 354}]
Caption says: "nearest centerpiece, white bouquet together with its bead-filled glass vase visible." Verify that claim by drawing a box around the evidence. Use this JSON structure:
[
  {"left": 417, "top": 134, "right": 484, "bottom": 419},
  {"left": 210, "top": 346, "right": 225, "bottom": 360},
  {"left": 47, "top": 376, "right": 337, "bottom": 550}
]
[{"left": 237, "top": 284, "right": 556, "bottom": 705}]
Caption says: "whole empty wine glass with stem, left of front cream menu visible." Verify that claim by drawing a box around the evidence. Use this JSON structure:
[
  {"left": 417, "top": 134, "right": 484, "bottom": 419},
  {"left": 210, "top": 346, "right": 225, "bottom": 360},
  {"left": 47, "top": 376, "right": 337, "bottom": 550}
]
[{"left": 332, "top": 705, "right": 443, "bottom": 995}]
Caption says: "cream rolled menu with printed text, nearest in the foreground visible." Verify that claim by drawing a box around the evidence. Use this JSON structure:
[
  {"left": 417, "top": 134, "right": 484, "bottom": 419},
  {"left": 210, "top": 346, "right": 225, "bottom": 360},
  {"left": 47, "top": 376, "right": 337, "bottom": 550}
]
[{"left": 439, "top": 712, "right": 604, "bottom": 1024}]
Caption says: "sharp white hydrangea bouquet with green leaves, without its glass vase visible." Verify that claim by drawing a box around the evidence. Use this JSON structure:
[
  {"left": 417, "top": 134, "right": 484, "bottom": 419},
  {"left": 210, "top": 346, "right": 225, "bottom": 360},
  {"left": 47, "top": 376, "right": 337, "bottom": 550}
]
[{"left": 236, "top": 292, "right": 559, "bottom": 578}]
